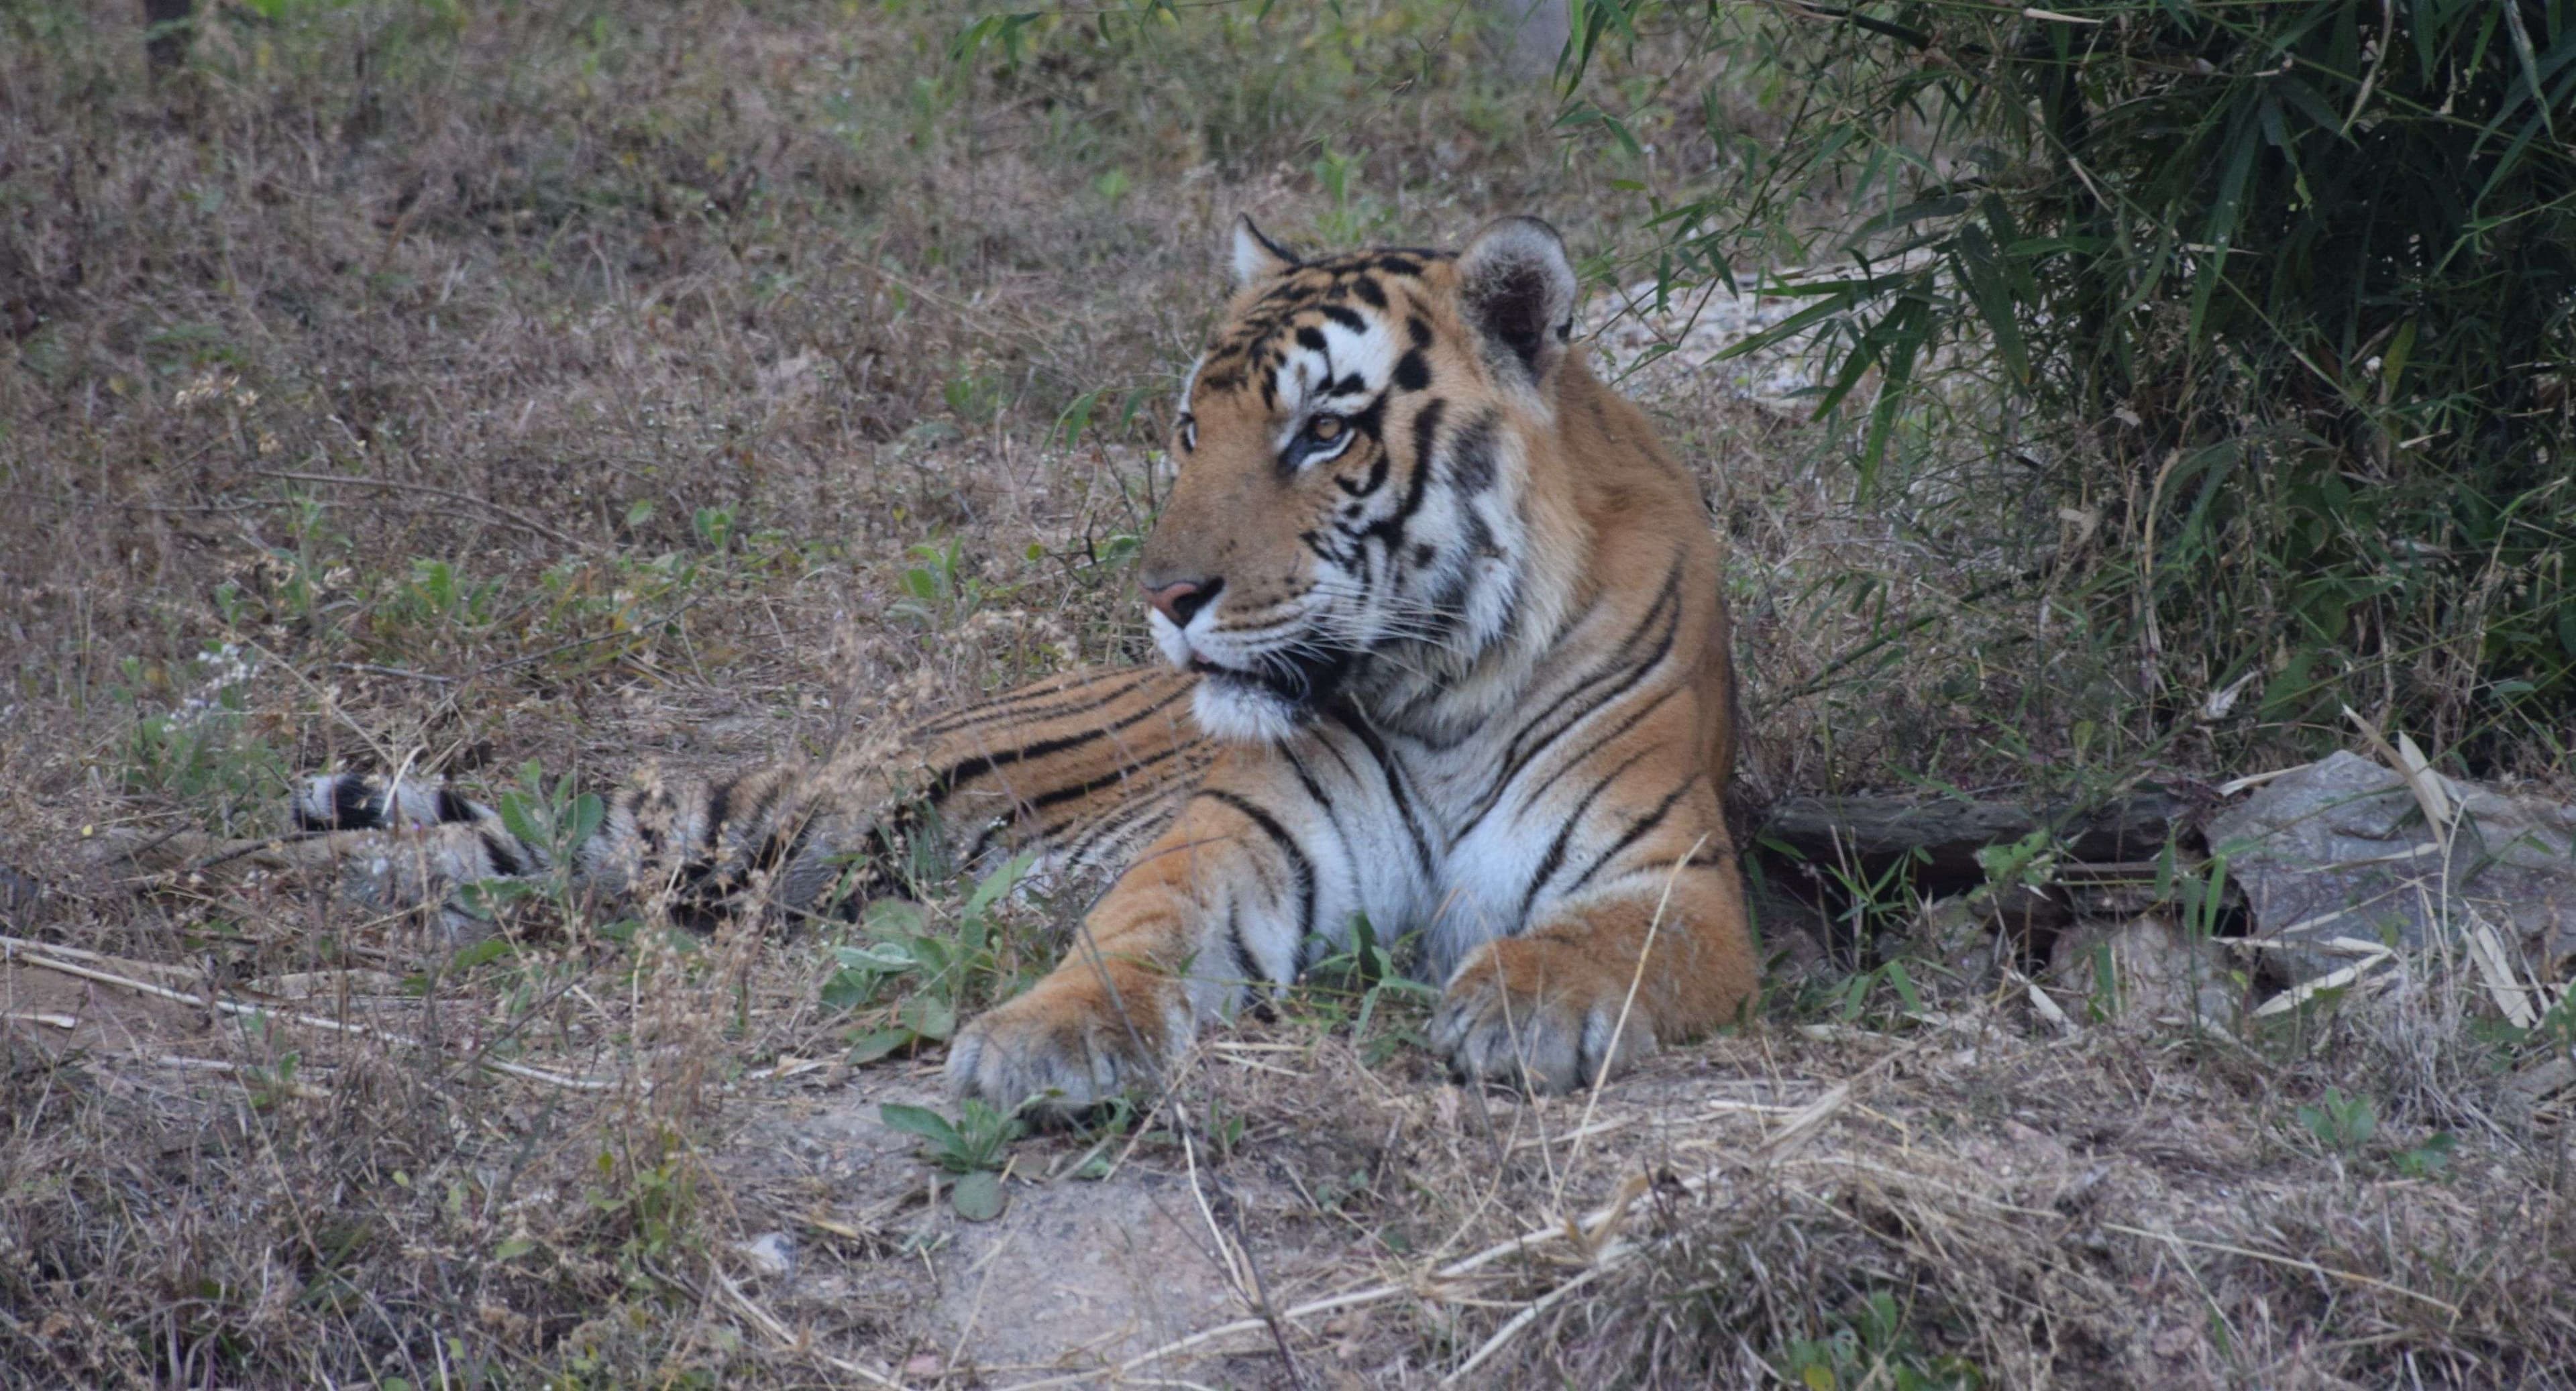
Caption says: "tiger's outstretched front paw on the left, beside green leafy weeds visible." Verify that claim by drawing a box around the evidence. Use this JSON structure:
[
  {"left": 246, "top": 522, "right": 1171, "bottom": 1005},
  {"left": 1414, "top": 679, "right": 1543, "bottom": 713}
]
[{"left": 948, "top": 963, "right": 1190, "bottom": 1113}]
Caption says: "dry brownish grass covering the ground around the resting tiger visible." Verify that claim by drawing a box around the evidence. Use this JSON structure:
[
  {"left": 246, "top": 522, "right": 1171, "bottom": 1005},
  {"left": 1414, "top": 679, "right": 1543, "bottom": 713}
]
[{"left": 0, "top": 0, "right": 2576, "bottom": 1386}]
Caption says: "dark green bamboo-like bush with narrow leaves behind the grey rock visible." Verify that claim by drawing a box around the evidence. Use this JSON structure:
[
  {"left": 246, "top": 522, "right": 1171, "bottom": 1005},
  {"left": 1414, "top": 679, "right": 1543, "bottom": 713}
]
[{"left": 1607, "top": 0, "right": 2576, "bottom": 752}]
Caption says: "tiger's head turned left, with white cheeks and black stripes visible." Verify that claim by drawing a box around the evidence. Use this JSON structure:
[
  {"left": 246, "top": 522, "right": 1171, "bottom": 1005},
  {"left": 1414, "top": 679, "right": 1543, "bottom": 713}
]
[{"left": 1138, "top": 217, "right": 1579, "bottom": 742}]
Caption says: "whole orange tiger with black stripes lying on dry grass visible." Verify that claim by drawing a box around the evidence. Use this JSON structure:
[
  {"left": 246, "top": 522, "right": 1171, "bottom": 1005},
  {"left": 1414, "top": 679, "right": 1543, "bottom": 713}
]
[{"left": 100, "top": 217, "right": 1760, "bottom": 1113}]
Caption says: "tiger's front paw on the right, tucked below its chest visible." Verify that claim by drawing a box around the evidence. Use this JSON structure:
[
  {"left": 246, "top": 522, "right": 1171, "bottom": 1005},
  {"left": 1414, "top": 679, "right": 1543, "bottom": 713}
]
[{"left": 1430, "top": 938, "right": 1654, "bottom": 1092}]
